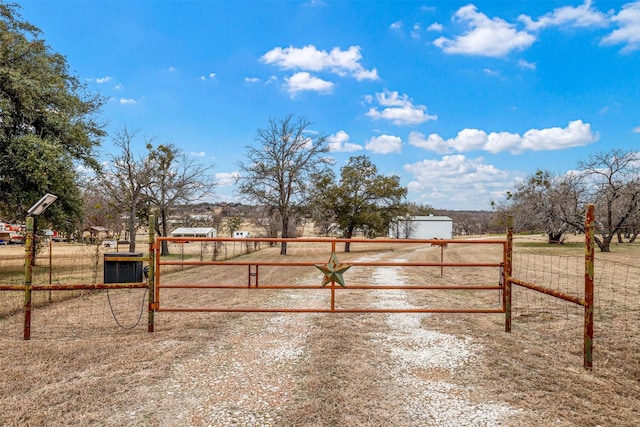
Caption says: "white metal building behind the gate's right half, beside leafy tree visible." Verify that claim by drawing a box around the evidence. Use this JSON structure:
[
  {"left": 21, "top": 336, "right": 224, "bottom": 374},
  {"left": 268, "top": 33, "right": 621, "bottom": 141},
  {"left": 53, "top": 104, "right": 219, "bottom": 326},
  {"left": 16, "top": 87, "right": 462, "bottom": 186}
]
[{"left": 389, "top": 215, "right": 453, "bottom": 240}]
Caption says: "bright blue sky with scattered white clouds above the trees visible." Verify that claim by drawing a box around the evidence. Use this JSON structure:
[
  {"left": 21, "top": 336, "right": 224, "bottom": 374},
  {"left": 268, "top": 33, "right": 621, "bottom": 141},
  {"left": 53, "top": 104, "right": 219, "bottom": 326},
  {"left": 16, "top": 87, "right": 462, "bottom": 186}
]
[{"left": 20, "top": 0, "right": 640, "bottom": 210}]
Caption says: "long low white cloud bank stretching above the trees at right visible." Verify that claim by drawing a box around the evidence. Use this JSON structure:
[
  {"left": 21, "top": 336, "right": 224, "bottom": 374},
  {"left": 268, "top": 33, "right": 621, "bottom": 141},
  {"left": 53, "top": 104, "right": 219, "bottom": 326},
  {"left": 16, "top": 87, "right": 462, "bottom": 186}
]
[{"left": 409, "top": 120, "right": 599, "bottom": 154}]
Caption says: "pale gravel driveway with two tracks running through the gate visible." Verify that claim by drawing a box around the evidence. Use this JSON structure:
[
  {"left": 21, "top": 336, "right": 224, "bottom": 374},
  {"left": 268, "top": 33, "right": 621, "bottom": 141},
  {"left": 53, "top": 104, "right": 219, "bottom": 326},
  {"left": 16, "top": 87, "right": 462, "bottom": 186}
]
[{"left": 118, "top": 252, "right": 521, "bottom": 426}]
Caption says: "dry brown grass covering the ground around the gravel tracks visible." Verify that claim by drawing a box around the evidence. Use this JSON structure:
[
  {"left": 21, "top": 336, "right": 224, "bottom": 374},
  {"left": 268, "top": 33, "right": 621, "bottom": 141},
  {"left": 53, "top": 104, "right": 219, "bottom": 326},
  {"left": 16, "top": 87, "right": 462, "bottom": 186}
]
[{"left": 0, "top": 239, "right": 640, "bottom": 426}]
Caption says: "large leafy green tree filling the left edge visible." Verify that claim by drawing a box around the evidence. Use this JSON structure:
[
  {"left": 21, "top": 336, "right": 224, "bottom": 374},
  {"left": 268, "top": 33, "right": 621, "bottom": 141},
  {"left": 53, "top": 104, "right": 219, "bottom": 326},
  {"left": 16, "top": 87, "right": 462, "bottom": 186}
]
[{"left": 0, "top": 2, "right": 105, "bottom": 226}]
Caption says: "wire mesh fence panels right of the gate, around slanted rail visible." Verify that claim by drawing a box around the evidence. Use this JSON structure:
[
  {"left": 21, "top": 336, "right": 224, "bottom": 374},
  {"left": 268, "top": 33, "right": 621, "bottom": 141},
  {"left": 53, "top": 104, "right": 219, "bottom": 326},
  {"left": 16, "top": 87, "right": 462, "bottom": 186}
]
[{"left": 513, "top": 252, "right": 640, "bottom": 373}]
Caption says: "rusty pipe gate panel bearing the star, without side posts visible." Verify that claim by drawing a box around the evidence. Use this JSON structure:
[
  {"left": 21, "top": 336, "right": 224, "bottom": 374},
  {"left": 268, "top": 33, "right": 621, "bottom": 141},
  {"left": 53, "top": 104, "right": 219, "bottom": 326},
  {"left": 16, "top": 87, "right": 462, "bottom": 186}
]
[{"left": 152, "top": 237, "right": 507, "bottom": 313}]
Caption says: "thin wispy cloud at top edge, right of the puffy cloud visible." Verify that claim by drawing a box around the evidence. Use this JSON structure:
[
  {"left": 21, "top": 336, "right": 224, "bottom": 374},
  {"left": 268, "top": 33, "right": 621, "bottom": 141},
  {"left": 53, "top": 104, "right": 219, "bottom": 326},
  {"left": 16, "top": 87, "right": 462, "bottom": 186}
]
[{"left": 518, "top": 0, "right": 609, "bottom": 31}]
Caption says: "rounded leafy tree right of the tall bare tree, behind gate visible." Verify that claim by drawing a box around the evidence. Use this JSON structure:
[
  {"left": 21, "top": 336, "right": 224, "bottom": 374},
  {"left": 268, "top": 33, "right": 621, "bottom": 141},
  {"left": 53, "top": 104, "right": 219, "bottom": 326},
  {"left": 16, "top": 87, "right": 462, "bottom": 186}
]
[{"left": 315, "top": 155, "right": 407, "bottom": 252}]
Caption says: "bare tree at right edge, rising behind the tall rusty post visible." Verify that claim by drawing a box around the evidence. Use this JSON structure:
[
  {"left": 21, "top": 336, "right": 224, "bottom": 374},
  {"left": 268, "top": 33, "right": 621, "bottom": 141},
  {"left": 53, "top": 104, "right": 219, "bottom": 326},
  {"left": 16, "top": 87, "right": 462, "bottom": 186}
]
[{"left": 579, "top": 149, "right": 640, "bottom": 252}]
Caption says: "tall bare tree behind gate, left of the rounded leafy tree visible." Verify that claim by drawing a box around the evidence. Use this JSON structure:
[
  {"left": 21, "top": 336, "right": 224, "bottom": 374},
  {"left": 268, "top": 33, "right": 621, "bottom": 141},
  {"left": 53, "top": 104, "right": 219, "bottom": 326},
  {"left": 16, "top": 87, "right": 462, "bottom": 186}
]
[{"left": 238, "top": 115, "right": 331, "bottom": 255}]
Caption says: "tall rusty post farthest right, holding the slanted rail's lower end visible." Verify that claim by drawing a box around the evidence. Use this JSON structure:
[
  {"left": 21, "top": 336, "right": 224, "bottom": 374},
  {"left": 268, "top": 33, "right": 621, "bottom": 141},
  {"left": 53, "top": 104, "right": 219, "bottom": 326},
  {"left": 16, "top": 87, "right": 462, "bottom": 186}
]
[{"left": 583, "top": 205, "right": 595, "bottom": 370}]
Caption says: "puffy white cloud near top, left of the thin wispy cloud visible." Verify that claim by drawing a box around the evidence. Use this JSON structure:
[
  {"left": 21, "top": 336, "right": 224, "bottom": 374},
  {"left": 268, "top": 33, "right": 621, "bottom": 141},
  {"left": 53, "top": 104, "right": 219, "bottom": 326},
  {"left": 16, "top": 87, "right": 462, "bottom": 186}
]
[{"left": 433, "top": 5, "right": 535, "bottom": 57}]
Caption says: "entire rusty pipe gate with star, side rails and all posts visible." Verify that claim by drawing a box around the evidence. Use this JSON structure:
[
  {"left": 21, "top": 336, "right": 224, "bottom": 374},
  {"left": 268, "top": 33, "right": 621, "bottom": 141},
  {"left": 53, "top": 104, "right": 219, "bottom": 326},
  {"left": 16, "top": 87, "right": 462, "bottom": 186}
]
[{"left": 0, "top": 212, "right": 595, "bottom": 369}]
